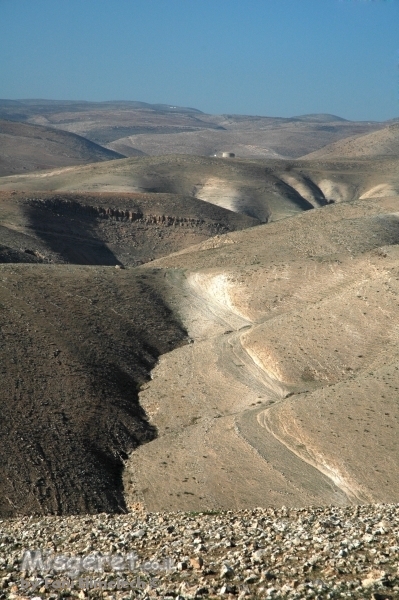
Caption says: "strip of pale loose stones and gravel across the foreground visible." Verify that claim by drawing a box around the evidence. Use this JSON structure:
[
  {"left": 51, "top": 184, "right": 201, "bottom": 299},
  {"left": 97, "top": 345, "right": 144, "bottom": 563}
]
[{"left": 0, "top": 504, "right": 399, "bottom": 600}]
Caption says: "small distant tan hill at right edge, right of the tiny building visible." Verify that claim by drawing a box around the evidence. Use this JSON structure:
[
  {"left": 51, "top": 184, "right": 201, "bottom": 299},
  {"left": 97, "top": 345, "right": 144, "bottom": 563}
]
[{"left": 302, "top": 123, "right": 399, "bottom": 160}]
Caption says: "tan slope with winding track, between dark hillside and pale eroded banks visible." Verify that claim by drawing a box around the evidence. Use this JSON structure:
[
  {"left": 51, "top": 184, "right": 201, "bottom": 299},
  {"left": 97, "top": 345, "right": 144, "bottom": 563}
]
[{"left": 125, "top": 270, "right": 356, "bottom": 510}]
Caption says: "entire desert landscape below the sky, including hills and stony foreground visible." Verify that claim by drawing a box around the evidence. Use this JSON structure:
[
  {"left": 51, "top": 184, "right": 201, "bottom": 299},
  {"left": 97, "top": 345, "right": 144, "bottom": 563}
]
[{"left": 0, "top": 101, "right": 399, "bottom": 600}]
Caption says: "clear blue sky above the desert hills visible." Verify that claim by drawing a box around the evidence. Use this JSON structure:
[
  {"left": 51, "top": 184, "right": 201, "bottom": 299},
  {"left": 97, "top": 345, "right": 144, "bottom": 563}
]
[{"left": 0, "top": 0, "right": 399, "bottom": 120}]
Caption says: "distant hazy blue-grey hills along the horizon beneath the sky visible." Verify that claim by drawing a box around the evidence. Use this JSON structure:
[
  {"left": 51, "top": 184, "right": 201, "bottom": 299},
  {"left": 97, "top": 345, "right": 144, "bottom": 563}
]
[{"left": 0, "top": 100, "right": 386, "bottom": 158}]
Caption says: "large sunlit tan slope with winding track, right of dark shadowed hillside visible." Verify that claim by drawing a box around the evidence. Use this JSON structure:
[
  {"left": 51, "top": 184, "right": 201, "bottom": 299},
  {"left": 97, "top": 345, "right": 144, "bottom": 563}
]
[{"left": 124, "top": 197, "right": 399, "bottom": 510}]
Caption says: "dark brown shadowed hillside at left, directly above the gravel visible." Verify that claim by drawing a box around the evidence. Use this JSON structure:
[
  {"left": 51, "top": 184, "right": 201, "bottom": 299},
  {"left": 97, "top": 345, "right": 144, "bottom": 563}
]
[{"left": 0, "top": 265, "right": 185, "bottom": 517}]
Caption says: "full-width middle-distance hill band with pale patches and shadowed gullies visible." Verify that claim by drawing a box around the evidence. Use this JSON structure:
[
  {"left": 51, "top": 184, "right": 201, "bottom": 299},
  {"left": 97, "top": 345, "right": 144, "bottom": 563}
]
[{"left": 0, "top": 155, "right": 399, "bottom": 222}]
